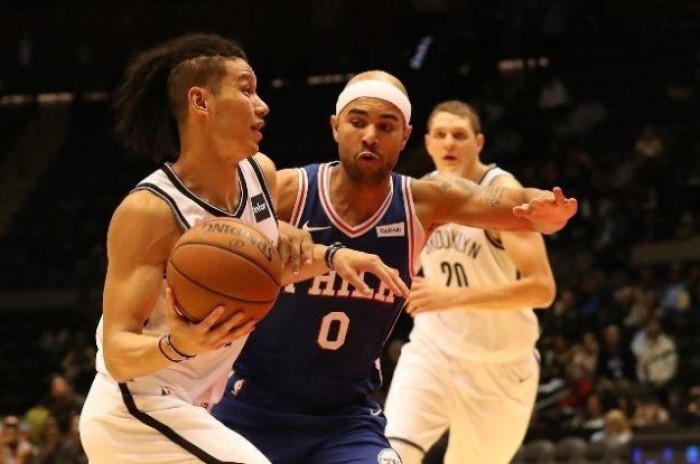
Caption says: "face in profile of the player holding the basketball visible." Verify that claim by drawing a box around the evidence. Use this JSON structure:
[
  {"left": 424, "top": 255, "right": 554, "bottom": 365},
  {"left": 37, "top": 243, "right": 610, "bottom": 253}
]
[{"left": 207, "top": 59, "right": 270, "bottom": 159}]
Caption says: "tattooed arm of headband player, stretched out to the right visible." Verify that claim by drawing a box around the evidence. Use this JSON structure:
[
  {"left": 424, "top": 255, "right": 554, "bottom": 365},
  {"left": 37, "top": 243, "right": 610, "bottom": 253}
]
[{"left": 411, "top": 177, "right": 578, "bottom": 234}]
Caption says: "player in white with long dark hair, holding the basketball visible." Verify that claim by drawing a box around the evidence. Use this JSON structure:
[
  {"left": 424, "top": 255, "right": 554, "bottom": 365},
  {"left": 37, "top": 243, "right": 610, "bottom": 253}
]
[{"left": 80, "top": 34, "right": 407, "bottom": 464}]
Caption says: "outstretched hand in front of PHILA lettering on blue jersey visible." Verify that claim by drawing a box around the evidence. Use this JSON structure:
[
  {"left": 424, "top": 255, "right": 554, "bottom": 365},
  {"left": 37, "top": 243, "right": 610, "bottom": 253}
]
[{"left": 333, "top": 248, "right": 409, "bottom": 298}]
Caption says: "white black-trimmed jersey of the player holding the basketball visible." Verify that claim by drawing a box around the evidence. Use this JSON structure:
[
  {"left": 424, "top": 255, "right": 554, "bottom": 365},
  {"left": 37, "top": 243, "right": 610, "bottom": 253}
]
[{"left": 96, "top": 158, "right": 279, "bottom": 408}]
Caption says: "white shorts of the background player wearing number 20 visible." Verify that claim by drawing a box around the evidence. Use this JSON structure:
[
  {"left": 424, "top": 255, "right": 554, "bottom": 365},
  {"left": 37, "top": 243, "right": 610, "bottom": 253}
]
[{"left": 385, "top": 342, "right": 539, "bottom": 464}]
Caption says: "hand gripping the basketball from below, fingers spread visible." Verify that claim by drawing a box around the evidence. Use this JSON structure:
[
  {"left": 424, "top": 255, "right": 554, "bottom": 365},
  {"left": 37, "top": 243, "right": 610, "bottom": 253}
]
[{"left": 166, "top": 288, "right": 256, "bottom": 356}]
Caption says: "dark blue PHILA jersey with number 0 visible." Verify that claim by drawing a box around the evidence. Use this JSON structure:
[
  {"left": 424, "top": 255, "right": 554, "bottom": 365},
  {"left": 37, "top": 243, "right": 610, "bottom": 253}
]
[{"left": 229, "top": 162, "right": 424, "bottom": 414}]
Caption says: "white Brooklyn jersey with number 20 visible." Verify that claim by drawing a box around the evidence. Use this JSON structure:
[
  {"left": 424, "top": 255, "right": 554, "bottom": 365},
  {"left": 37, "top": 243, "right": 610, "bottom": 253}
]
[{"left": 411, "top": 166, "right": 539, "bottom": 361}]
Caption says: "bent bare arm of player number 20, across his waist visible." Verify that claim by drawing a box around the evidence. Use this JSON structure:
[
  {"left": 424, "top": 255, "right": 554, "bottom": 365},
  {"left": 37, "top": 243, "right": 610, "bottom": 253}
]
[{"left": 406, "top": 176, "right": 556, "bottom": 315}]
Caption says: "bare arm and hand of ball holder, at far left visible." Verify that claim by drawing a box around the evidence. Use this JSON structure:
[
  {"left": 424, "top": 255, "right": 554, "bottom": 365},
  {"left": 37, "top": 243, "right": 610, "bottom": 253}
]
[{"left": 102, "top": 191, "right": 251, "bottom": 382}]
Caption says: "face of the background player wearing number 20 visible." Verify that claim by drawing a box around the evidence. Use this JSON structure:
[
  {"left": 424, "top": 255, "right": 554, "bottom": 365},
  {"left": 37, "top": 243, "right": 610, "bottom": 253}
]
[{"left": 425, "top": 112, "right": 484, "bottom": 177}]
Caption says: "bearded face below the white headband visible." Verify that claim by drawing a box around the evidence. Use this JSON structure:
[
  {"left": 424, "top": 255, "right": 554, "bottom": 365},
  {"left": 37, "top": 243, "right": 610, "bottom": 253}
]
[{"left": 331, "top": 97, "right": 411, "bottom": 185}]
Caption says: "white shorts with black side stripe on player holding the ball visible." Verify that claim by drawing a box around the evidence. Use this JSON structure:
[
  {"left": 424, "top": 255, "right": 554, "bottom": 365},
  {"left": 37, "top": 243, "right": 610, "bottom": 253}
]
[{"left": 80, "top": 374, "right": 270, "bottom": 464}]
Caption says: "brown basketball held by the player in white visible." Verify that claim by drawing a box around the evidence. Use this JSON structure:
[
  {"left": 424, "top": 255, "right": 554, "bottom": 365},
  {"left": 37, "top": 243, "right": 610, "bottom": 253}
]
[{"left": 167, "top": 218, "right": 282, "bottom": 322}]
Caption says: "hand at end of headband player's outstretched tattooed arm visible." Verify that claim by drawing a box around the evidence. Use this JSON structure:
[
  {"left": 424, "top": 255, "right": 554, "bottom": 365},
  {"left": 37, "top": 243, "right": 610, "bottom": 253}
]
[{"left": 513, "top": 187, "right": 578, "bottom": 234}]
